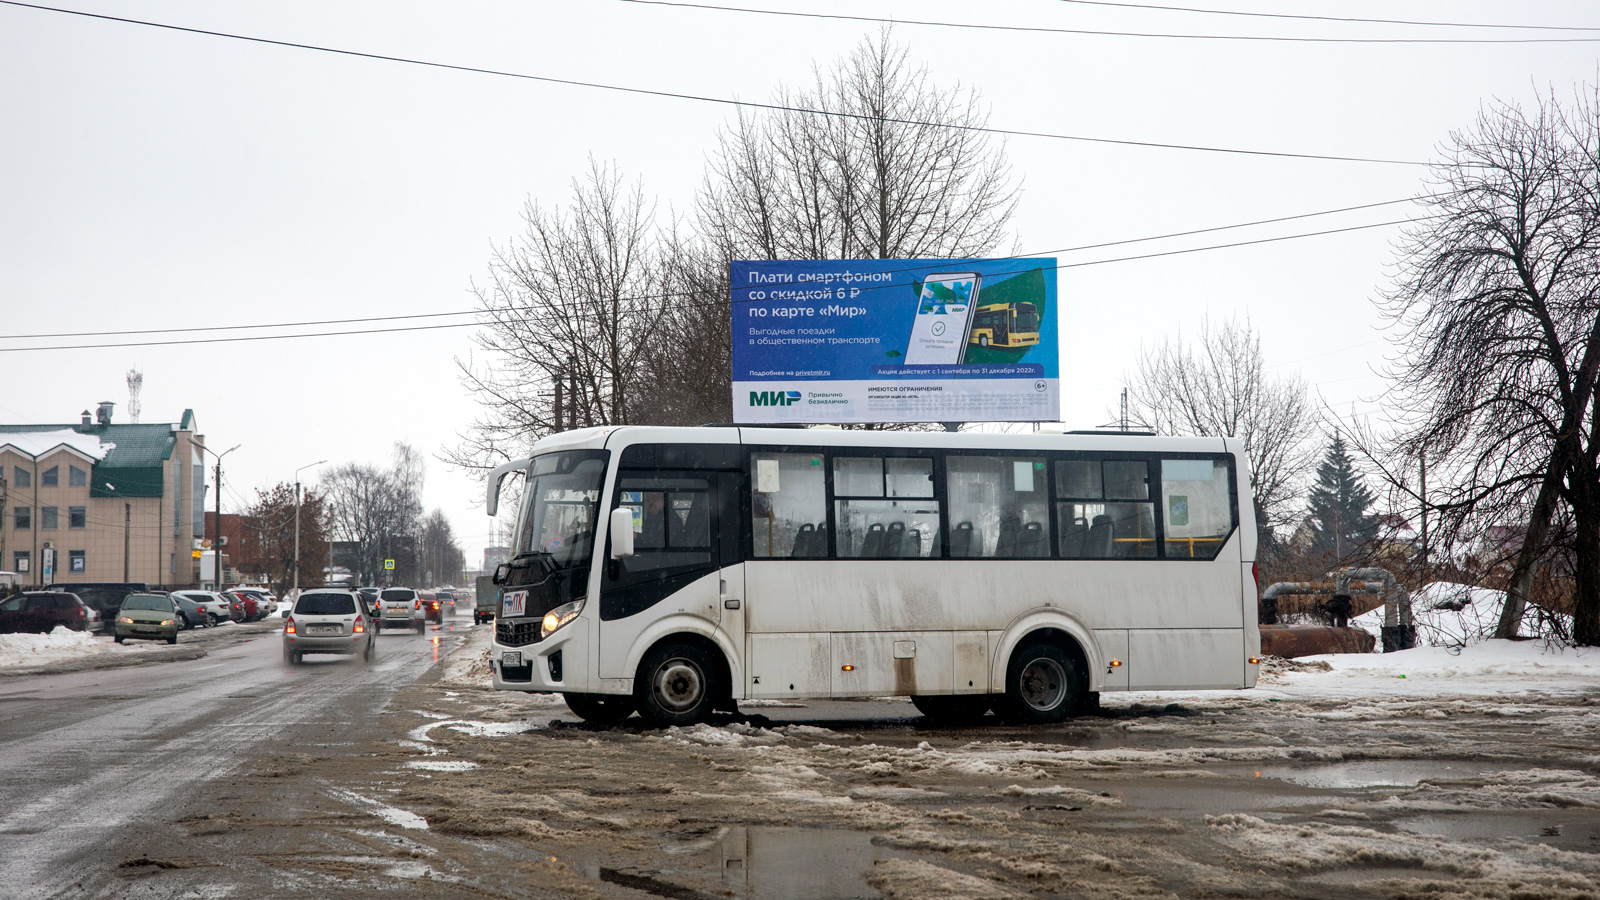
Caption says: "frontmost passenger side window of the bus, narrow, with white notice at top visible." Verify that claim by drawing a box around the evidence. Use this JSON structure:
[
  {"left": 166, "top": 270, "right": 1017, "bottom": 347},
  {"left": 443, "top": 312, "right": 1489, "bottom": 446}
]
[{"left": 750, "top": 453, "right": 827, "bottom": 559}]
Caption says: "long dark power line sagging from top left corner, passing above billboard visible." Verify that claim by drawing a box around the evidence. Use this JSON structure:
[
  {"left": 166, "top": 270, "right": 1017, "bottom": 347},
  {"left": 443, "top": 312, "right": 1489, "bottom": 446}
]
[{"left": 0, "top": 0, "right": 1427, "bottom": 165}]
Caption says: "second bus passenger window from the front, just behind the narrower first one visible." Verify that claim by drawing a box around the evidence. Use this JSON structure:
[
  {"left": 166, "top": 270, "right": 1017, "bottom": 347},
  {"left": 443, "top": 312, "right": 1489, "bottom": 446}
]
[{"left": 834, "top": 456, "right": 942, "bottom": 559}]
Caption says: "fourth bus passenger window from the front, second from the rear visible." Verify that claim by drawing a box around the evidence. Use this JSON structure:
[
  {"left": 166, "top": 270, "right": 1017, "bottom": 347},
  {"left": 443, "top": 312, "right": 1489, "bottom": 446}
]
[{"left": 1056, "top": 460, "right": 1155, "bottom": 559}]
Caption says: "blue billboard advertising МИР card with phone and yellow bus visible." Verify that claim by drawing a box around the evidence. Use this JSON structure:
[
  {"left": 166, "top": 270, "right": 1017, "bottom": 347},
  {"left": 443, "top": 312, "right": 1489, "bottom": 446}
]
[{"left": 730, "top": 258, "right": 1061, "bottom": 424}]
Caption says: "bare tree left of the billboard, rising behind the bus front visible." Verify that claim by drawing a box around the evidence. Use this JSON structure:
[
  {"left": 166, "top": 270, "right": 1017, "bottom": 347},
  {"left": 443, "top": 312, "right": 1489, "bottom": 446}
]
[{"left": 445, "top": 160, "right": 666, "bottom": 469}]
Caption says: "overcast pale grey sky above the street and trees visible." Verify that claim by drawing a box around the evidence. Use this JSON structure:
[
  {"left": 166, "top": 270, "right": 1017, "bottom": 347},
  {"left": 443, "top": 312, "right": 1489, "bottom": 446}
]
[{"left": 0, "top": 0, "right": 1600, "bottom": 560}]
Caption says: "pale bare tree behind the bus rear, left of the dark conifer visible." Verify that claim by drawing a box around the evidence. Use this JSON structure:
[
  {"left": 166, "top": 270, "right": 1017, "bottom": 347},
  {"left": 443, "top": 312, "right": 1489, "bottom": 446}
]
[{"left": 1126, "top": 319, "right": 1317, "bottom": 552}]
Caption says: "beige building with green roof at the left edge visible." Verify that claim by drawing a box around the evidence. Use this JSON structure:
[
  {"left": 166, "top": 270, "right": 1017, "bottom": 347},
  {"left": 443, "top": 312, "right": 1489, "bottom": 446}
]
[{"left": 0, "top": 404, "right": 206, "bottom": 588}]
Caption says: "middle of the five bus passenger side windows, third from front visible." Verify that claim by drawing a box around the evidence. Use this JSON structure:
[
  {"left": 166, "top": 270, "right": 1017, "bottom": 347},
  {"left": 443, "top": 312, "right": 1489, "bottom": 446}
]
[{"left": 946, "top": 456, "right": 1050, "bottom": 559}]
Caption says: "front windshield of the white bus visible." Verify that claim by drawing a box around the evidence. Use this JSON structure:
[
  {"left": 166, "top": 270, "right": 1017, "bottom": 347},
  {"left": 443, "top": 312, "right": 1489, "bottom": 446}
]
[{"left": 512, "top": 450, "right": 606, "bottom": 570}]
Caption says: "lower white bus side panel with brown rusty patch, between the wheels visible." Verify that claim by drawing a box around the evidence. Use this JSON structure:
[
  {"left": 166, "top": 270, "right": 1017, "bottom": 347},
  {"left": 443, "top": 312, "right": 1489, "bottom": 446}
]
[{"left": 829, "top": 631, "right": 955, "bottom": 697}]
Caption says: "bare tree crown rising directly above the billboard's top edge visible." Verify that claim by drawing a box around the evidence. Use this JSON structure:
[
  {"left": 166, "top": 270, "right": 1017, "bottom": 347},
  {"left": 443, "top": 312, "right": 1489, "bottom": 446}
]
[{"left": 698, "top": 29, "right": 1019, "bottom": 259}]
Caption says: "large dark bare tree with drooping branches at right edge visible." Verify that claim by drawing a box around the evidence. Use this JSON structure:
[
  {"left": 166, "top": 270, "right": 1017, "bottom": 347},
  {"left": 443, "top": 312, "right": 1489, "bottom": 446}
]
[{"left": 1386, "top": 88, "right": 1600, "bottom": 644}]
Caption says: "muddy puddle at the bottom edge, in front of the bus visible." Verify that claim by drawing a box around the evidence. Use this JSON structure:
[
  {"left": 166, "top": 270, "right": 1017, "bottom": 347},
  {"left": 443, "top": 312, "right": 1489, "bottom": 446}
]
[{"left": 578, "top": 825, "right": 907, "bottom": 900}]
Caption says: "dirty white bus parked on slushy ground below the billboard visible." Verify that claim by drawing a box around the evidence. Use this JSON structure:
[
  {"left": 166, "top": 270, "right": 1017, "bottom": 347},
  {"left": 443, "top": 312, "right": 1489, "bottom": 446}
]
[{"left": 488, "top": 426, "right": 1261, "bottom": 724}]
